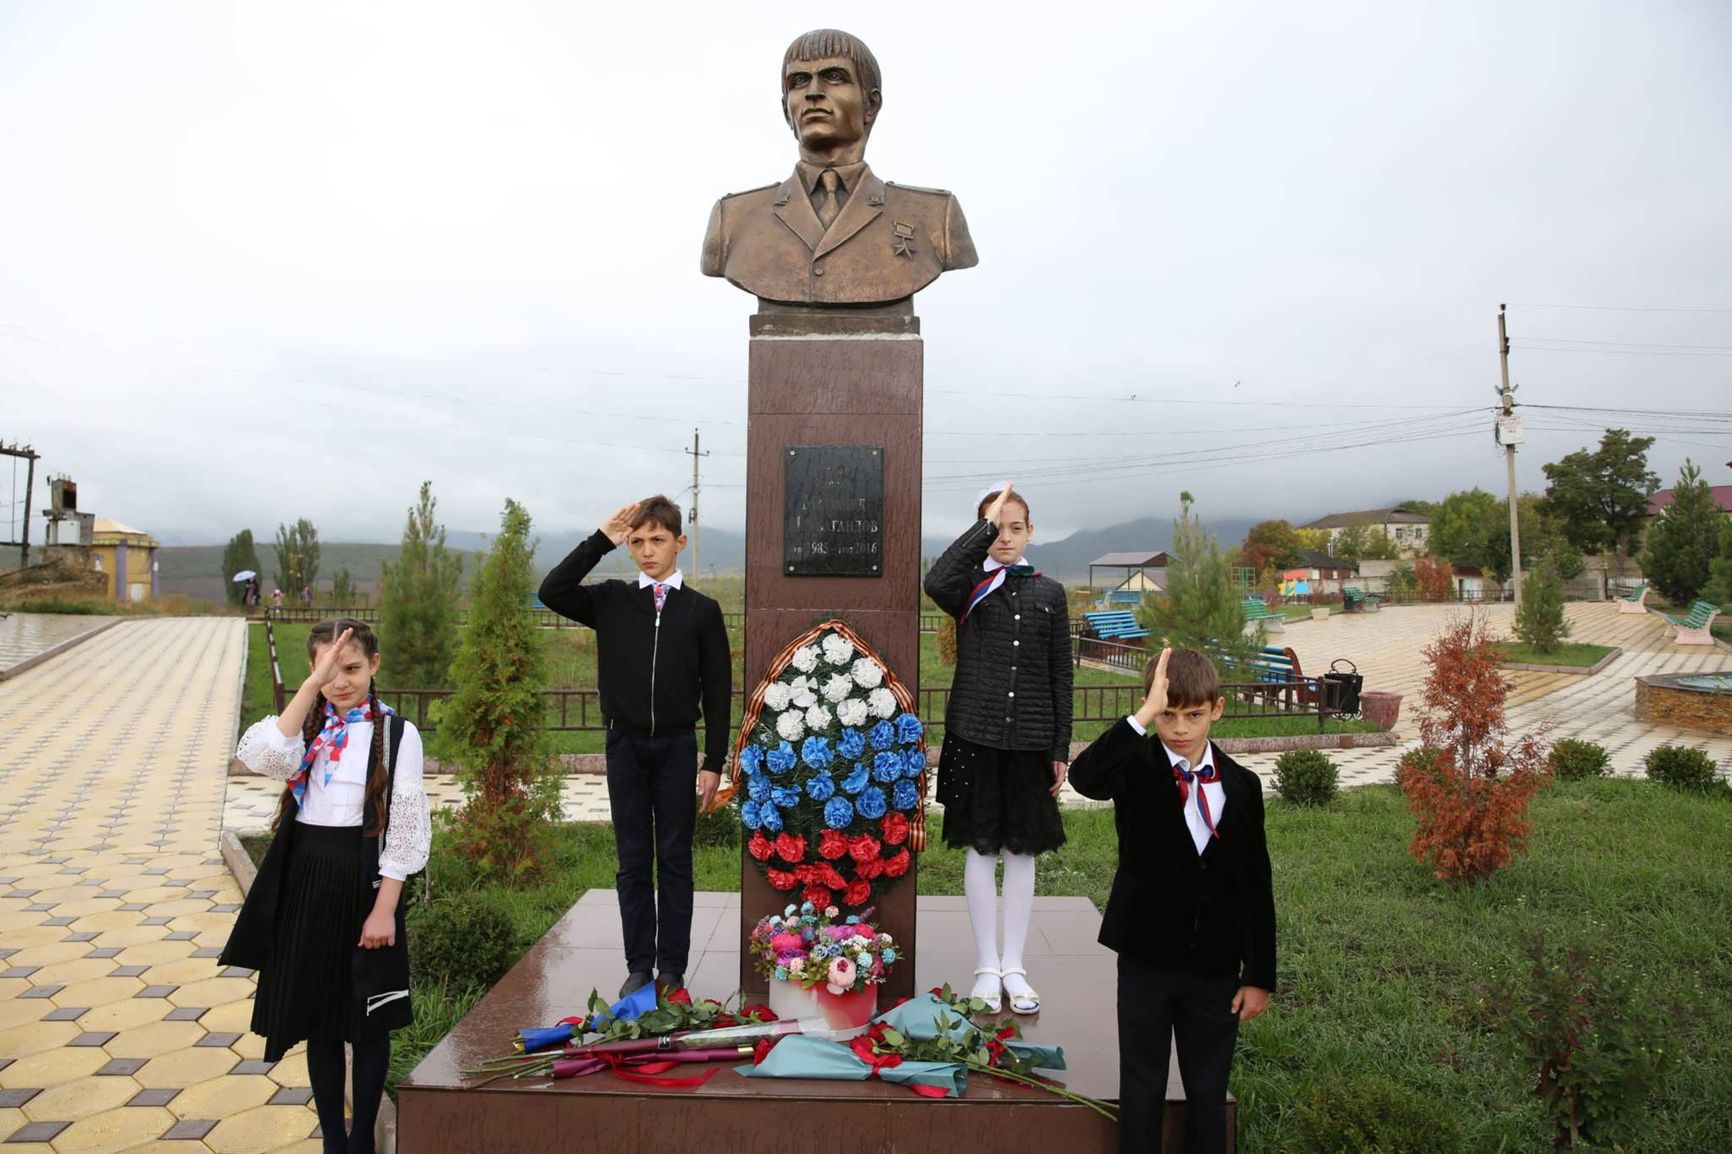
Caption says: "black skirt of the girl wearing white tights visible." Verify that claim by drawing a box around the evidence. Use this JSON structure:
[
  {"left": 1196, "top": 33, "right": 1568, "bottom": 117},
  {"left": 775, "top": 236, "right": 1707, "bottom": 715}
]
[{"left": 939, "top": 733, "right": 1065, "bottom": 854}]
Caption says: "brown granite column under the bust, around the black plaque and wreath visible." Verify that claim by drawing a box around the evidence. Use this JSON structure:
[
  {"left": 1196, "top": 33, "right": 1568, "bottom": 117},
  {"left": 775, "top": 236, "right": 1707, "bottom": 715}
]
[{"left": 740, "top": 310, "right": 923, "bottom": 1005}]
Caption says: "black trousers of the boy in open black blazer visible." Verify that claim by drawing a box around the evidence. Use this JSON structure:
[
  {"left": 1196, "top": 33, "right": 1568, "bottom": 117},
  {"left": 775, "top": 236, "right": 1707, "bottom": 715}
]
[{"left": 1119, "top": 955, "right": 1238, "bottom": 1154}]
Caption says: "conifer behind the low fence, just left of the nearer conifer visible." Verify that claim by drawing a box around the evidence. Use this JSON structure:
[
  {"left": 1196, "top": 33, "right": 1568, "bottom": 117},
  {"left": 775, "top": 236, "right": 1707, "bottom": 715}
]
[{"left": 379, "top": 482, "right": 462, "bottom": 690}]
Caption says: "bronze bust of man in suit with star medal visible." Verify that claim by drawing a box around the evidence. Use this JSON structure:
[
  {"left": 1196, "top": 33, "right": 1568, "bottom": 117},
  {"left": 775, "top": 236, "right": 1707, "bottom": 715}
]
[{"left": 703, "top": 28, "right": 979, "bottom": 307}]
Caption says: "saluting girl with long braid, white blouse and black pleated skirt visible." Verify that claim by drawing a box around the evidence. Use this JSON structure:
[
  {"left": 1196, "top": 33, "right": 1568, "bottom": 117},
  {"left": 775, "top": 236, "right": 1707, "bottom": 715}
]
[{"left": 220, "top": 619, "right": 433, "bottom": 1154}]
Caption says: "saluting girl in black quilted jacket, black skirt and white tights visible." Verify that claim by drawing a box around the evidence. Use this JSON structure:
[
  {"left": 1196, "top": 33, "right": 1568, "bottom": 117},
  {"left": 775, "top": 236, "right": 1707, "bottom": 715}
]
[{"left": 927, "top": 482, "right": 1070, "bottom": 1014}]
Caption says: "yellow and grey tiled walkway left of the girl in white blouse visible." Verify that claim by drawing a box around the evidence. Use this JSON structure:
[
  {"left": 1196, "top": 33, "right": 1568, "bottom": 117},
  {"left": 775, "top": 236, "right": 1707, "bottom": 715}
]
[{"left": 0, "top": 619, "right": 320, "bottom": 1154}]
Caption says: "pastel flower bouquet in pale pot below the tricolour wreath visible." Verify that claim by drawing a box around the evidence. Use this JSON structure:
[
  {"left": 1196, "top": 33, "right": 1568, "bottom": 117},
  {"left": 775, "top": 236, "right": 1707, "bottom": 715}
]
[{"left": 746, "top": 901, "right": 899, "bottom": 1038}]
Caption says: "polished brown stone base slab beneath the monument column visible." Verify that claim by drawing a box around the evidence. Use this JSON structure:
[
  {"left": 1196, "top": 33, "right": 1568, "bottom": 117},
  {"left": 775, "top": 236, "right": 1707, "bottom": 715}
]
[{"left": 397, "top": 891, "right": 1235, "bottom": 1154}]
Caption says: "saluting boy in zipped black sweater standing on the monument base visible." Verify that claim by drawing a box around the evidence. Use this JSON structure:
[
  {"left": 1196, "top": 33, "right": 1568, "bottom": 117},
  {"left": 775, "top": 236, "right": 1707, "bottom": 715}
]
[{"left": 540, "top": 496, "right": 733, "bottom": 998}]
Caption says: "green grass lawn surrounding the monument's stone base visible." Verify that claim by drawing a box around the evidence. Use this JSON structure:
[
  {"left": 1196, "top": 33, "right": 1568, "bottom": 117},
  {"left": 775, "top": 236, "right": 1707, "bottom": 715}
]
[{"left": 372, "top": 780, "right": 1732, "bottom": 1154}]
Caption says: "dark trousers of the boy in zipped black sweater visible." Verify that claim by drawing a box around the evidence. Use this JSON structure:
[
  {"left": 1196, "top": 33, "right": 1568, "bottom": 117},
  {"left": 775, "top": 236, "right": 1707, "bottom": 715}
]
[{"left": 608, "top": 729, "right": 698, "bottom": 974}]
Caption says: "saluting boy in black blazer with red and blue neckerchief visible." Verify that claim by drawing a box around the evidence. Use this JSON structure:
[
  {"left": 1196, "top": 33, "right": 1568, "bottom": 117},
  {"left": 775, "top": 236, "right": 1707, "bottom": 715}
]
[{"left": 1070, "top": 650, "right": 1275, "bottom": 1154}]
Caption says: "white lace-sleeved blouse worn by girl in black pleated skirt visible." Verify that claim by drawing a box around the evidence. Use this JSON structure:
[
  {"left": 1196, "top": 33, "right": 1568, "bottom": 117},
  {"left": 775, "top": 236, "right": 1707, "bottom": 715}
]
[{"left": 234, "top": 714, "right": 433, "bottom": 882}]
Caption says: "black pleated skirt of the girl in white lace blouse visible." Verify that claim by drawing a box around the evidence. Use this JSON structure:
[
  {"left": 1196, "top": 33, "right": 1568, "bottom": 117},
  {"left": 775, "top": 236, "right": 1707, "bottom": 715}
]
[{"left": 253, "top": 821, "right": 368, "bottom": 1062}]
